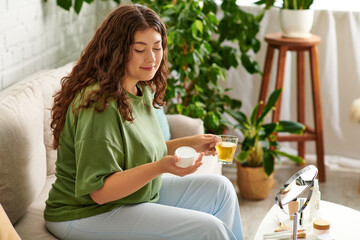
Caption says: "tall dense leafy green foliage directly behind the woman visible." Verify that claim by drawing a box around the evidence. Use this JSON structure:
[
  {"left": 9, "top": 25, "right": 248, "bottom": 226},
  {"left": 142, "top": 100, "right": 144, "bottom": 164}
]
[{"left": 143, "top": 0, "right": 265, "bottom": 134}]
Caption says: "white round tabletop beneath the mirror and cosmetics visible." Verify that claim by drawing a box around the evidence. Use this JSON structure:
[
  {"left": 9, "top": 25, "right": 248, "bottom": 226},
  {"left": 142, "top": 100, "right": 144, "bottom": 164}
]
[{"left": 254, "top": 201, "right": 360, "bottom": 240}]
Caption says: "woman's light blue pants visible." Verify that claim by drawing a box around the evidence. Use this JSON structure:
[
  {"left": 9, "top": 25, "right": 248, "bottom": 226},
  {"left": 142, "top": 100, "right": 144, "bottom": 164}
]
[{"left": 46, "top": 174, "right": 243, "bottom": 240}]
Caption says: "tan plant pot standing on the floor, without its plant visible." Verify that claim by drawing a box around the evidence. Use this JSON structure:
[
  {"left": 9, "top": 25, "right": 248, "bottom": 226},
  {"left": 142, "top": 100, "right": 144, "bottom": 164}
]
[{"left": 236, "top": 162, "right": 274, "bottom": 200}]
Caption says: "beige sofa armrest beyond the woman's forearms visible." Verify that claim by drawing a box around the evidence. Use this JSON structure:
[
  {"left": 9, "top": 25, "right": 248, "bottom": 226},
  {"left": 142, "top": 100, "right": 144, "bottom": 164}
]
[{"left": 166, "top": 114, "right": 204, "bottom": 139}]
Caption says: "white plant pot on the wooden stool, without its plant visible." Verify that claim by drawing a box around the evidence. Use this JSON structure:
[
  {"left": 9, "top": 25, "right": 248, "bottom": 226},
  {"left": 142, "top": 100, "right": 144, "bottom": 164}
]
[{"left": 280, "top": 9, "right": 314, "bottom": 38}]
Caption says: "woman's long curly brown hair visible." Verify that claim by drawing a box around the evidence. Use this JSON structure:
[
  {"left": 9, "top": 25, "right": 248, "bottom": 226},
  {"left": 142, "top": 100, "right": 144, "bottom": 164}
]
[{"left": 50, "top": 4, "right": 168, "bottom": 149}]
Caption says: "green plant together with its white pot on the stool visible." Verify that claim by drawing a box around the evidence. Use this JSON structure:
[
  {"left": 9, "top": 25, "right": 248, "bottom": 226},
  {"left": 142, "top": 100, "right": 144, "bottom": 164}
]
[{"left": 255, "top": 0, "right": 314, "bottom": 38}]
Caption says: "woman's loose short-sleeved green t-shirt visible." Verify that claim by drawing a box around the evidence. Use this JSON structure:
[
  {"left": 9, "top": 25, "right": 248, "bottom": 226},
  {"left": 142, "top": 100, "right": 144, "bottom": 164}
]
[{"left": 44, "top": 87, "right": 167, "bottom": 221}]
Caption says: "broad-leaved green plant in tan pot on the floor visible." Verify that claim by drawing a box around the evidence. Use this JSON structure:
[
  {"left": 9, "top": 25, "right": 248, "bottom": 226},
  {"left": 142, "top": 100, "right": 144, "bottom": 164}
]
[{"left": 227, "top": 89, "right": 305, "bottom": 200}]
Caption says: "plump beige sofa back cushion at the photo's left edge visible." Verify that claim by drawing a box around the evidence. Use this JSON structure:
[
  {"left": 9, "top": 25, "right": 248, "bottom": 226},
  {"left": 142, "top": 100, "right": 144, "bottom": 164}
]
[{"left": 0, "top": 78, "right": 46, "bottom": 223}]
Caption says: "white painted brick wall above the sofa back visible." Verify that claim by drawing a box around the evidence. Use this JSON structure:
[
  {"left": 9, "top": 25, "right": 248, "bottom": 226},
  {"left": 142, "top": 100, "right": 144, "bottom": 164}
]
[{"left": 0, "top": 0, "right": 116, "bottom": 91}]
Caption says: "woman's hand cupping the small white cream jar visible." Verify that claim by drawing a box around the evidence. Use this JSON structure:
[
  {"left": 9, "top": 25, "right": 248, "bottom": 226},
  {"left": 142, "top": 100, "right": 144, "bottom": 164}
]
[{"left": 155, "top": 153, "right": 204, "bottom": 177}]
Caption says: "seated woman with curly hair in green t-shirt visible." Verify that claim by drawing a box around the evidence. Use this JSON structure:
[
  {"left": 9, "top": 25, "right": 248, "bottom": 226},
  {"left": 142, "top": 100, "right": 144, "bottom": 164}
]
[{"left": 44, "top": 5, "right": 242, "bottom": 240}]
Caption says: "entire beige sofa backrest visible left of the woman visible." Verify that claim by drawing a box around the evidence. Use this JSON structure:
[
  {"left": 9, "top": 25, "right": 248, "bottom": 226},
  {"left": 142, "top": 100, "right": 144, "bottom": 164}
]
[{"left": 0, "top": 63, "right": 73, "bottom": 223}]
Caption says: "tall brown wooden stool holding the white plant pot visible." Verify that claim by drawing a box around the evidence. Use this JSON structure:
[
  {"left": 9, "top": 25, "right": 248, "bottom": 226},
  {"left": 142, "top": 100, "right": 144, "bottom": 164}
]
[{"left": 259, "top": 33, "right": 326, "bottom": 182}]
